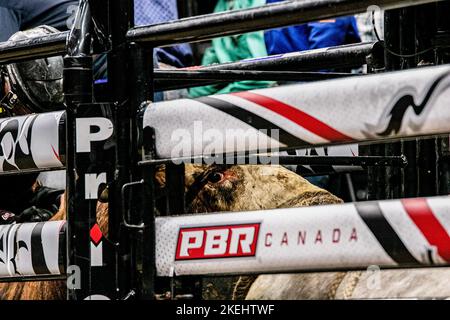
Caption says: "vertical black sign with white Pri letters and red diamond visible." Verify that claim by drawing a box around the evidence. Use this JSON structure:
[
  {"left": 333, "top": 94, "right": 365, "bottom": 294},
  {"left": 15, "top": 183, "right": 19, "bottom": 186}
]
[{"left": 67, "top": 103, "right": 116, "bottom": 300}]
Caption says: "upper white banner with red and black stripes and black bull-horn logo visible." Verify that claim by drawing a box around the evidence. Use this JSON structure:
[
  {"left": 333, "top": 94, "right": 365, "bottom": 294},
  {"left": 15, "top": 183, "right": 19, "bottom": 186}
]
[{"left": 143, "top": 66, "right": 450, "bottom": 158}]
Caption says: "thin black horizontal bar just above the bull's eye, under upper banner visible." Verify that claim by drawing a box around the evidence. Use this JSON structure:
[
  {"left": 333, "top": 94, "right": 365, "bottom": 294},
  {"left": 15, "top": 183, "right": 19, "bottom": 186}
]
[{"left": 138, "top": 154, "right": 408, "bottom": 167}]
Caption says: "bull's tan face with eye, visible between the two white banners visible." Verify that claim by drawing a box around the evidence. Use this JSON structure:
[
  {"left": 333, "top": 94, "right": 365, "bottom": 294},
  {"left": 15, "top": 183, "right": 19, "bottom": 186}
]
[{"left": 157, "top": 165, "right": 341, "bottom": 213}]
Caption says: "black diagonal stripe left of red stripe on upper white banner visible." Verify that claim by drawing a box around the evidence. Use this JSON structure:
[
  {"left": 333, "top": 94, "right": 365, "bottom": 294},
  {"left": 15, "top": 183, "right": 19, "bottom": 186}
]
[{"left": 195, "top": 97, "right": 310, "bottom": 147}]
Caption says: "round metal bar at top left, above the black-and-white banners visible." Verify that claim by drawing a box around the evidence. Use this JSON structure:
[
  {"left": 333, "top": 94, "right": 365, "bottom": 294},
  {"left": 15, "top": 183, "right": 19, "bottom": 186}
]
[{"left": 0, "top": 32, "right": 69, "bottom": 64}]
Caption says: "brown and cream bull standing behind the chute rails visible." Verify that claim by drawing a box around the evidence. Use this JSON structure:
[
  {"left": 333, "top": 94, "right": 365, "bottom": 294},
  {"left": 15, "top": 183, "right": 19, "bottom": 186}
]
[{"left": 0, "top": 165, "right": 450, "bottom": 300}]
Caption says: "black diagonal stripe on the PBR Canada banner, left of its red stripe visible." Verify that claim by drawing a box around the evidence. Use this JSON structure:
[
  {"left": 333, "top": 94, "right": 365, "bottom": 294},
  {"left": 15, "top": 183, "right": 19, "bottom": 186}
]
[{"left": 355, "top": 202, "right": 420, "bottom": 265}]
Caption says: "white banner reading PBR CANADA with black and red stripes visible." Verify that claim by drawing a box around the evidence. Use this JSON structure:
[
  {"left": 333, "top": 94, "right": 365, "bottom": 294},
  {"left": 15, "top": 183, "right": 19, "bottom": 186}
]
[{"left": 156, "top": 197, "right": 450, "bottom": 276}]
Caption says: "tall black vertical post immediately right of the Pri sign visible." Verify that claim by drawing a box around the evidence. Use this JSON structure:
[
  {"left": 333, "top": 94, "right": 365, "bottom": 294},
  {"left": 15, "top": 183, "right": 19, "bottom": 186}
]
[{"left": 107, "top": 0, "right": 136, "bottom": 296}]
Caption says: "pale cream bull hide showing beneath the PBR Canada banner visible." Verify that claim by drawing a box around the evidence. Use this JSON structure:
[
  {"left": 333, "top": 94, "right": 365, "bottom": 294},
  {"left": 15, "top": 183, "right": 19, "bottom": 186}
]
[{"left": 245, "top": 268, "right": 450, "bottom": 300}]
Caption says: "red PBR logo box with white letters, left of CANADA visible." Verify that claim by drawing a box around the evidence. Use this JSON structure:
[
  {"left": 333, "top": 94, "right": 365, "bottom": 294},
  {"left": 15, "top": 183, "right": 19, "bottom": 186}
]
[{"left": 175, "top": 223, "right": 260, "bottom": 260}]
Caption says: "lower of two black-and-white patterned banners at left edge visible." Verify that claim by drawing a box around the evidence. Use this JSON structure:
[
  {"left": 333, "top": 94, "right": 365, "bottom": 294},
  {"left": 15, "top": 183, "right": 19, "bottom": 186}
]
[{"left": 0, "top": 221, "right": 66, "bottom": 278}]
